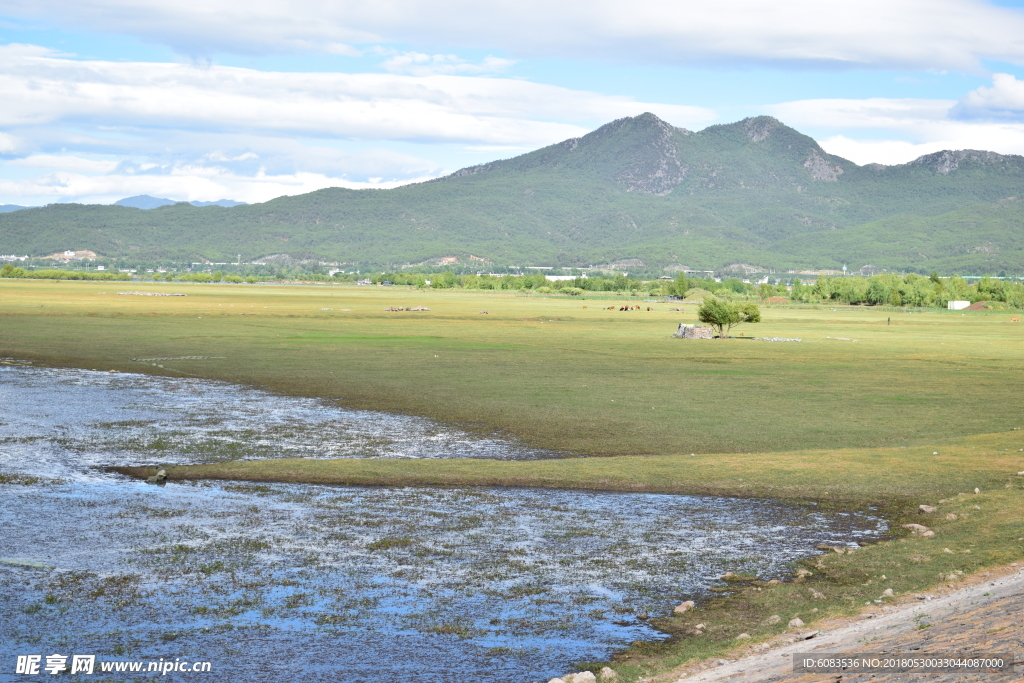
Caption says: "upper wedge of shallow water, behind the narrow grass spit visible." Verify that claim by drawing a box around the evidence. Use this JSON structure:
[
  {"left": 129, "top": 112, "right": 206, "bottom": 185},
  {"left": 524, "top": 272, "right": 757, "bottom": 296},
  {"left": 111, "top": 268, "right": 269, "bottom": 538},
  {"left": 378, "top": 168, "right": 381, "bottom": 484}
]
[{"left": 0, "top": 366, "right": 558, "bottom": 477}]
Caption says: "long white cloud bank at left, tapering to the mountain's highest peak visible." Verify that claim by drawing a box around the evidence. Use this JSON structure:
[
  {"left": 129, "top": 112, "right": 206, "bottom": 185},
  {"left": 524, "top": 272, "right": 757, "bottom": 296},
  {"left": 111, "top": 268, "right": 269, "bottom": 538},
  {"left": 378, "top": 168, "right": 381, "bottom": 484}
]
[{"left": 0, "top": 46, "right": 714, "bottom": 146}]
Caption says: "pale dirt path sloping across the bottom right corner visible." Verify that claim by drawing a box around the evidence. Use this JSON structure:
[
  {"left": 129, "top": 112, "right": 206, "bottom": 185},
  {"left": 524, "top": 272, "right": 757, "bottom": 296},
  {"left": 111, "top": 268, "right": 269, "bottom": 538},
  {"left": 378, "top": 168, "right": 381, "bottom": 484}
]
[{"left": 649, "top": 564, "right": 1024, "bottom": 683}]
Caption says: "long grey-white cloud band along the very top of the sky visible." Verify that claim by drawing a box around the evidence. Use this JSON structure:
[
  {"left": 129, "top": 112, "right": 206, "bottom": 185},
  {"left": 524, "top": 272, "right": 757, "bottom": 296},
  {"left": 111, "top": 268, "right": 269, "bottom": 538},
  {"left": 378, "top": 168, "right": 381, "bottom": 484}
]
[{"left": 4, "top": 0, "right": 1024, "bottom": 71}]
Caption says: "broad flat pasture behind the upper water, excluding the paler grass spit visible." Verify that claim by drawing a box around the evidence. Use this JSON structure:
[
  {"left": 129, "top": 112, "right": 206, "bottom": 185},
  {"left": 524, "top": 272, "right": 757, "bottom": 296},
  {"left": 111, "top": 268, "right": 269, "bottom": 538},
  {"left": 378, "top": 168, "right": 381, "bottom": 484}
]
[{"left": 0, "top": 281, "right": 1024, "bottom": 456}]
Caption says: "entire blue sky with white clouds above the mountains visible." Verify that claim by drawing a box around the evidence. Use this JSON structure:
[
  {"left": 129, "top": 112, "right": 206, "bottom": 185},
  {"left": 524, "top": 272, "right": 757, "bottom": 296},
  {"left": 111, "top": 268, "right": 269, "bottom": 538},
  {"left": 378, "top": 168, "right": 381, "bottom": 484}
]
[{"left": 0, "top": 0, "right": 1024, "bottom": 206}]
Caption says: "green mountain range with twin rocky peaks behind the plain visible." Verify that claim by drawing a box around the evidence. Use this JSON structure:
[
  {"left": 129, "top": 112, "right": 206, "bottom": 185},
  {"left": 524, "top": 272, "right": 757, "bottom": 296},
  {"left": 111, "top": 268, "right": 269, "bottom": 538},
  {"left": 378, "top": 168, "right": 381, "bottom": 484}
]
[{"left": 0, "top": 114, "right": 1024, "bottom": 272}]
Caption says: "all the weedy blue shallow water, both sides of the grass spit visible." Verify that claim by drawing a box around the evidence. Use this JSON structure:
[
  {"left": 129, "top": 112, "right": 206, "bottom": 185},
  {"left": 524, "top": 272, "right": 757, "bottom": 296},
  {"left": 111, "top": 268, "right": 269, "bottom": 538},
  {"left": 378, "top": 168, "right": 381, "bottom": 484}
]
[{"left": 0, "top": 369, "right": 885, "bottom": 683}]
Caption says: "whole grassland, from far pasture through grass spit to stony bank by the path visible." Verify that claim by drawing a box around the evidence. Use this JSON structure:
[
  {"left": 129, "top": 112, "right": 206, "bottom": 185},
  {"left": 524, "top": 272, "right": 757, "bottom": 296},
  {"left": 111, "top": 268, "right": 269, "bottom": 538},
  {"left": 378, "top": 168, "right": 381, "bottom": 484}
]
[{"left": 6, "top": 281, "right": 1024, "bottom": 680}]
